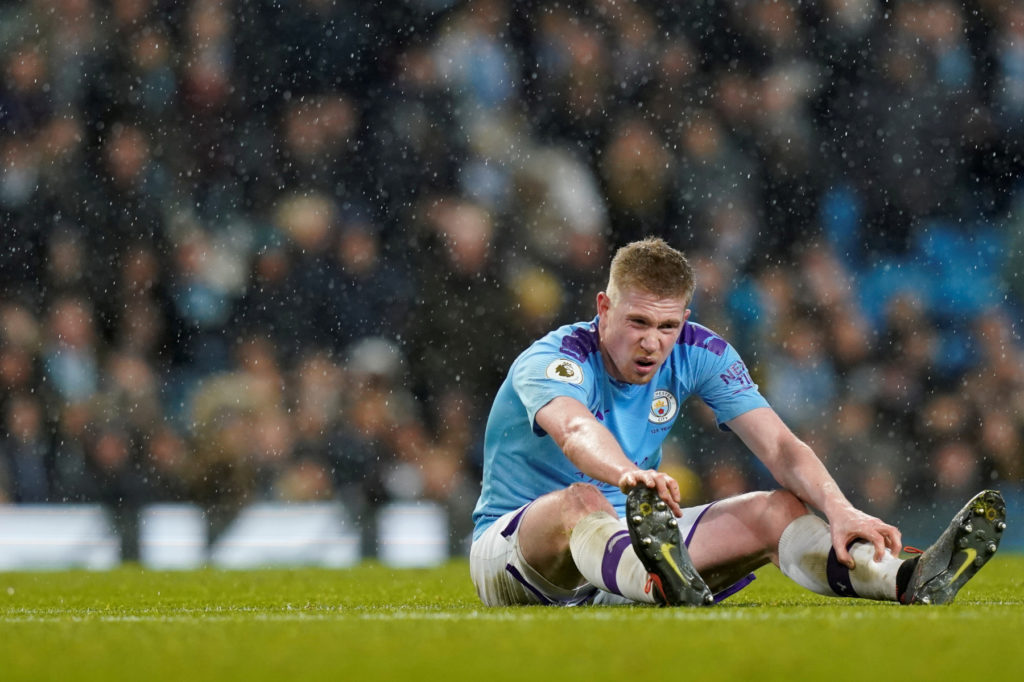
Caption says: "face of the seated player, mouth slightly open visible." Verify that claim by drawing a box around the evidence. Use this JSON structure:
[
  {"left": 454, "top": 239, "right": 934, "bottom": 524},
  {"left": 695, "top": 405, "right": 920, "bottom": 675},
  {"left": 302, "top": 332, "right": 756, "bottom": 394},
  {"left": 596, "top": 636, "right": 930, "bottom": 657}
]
[{"left": 597, "top": 289, "right": 690, "bottom": 384}]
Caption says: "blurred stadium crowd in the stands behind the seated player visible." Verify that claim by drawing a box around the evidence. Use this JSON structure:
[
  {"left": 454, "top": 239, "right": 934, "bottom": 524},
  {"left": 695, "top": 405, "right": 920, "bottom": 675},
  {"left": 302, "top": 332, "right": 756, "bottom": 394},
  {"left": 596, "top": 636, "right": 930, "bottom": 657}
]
[{"left": 0, "top": 0, "right": 1024, "bottom": 548}]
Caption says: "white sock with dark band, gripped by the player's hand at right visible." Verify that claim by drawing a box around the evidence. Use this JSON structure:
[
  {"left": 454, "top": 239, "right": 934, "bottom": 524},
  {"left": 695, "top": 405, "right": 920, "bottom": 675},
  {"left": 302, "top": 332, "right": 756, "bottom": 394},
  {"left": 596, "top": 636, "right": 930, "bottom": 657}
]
[{"left": 778, "top": 514, "right": 903, "bottom": 601}]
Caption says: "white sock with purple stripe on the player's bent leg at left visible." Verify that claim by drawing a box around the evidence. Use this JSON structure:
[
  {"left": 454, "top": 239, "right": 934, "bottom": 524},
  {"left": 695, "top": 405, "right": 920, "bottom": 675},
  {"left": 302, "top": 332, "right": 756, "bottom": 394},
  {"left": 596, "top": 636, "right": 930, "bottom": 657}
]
[{"left": 569, "top": 511, "right": 654, "bottom": 604}]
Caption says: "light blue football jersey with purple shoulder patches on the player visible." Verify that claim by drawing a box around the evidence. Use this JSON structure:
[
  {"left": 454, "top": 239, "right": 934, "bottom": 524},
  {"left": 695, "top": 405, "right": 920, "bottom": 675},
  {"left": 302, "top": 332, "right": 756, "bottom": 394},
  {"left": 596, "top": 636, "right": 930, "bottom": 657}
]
[{"left": 473, "top": 317, "right": 768, "bottom": 540}]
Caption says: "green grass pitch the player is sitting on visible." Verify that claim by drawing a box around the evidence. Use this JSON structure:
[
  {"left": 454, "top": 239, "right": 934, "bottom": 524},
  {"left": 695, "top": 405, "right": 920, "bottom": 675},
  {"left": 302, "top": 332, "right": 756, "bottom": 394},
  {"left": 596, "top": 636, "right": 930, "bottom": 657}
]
[{"left": 0, "top": 554, "right": 1024, "bottom": 682}]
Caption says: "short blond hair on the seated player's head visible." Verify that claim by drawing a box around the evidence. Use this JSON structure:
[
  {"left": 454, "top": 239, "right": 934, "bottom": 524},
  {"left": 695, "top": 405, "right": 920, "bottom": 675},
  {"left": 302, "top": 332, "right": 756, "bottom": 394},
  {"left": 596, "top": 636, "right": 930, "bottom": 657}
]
[{"left": 606, "top": 237, "right": 696, "bottom": 304}]
